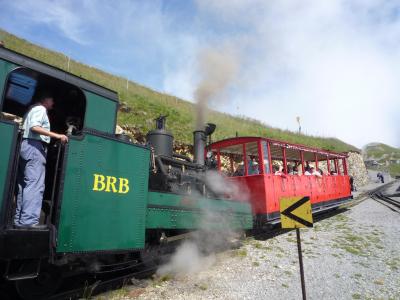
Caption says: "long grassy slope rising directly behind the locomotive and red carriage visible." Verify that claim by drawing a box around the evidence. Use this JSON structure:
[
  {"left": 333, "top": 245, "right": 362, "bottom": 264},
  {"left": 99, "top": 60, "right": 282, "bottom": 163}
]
[{"left": 0, "top": 29, "right": 358, "bottom": 151}]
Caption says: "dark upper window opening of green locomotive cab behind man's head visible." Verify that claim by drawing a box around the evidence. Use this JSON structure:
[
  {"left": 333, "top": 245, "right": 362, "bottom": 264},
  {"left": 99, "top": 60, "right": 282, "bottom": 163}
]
[{"left": 1, "top": 68, "right": 86, "bottom": 135}]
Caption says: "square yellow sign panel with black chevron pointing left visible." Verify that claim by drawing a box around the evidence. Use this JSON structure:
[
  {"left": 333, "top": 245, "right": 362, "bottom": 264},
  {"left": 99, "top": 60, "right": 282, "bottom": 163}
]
[{"left": 280, "top": 197, "right": 313, "bottom": 228}]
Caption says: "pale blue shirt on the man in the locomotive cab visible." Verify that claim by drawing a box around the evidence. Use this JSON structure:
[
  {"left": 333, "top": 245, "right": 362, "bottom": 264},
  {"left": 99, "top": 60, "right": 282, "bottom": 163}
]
[{"left": 22, "top": 104, "right": 50, "bottom": 143}]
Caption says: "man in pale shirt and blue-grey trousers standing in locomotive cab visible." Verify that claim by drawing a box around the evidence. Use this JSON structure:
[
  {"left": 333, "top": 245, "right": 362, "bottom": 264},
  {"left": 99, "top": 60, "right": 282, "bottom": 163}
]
[{"left": 14, "top": 93, "right": 68, "bottom": 228}]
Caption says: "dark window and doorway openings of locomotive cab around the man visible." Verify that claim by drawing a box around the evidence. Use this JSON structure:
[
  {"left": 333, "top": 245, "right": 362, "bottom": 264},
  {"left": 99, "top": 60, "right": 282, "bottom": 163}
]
[{"left": 1, "top": 67, "right": 86, "bottom": 228}]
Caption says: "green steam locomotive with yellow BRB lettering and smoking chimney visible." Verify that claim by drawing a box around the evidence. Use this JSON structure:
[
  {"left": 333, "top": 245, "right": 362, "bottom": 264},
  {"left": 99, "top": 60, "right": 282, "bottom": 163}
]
[{"left": 0, "top": 48, "right": 253, "bottom": 299}]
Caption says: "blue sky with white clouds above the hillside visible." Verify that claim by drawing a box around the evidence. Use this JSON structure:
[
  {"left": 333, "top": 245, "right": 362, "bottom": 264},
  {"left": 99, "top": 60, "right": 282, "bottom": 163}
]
[{"left": 0, "top": 0, "right": 400, "bottom": 147}]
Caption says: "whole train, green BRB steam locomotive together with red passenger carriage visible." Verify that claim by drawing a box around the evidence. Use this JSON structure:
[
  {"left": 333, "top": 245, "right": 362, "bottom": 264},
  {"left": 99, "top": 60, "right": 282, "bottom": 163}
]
[{"left": 0, "top": 48, "right": 351, "bottom": 299}]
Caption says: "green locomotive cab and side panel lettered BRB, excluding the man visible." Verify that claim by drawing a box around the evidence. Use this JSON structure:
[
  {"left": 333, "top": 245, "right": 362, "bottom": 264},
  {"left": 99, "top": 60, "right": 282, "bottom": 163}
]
[{"left": 0, "top": 48, "right": 142, "bottom": 286}]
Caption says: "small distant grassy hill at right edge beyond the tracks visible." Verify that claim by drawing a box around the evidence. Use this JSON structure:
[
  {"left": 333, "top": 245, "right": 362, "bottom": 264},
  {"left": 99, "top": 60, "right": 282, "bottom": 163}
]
[{"left": 363, "top": 143, "right": 400, "bottom": 176}]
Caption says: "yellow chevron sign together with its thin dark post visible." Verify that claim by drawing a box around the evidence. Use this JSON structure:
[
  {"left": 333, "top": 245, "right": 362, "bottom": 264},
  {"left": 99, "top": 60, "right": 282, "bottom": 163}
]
[{"left": 280, "top": 196, "right": 313, "bottom": 300}]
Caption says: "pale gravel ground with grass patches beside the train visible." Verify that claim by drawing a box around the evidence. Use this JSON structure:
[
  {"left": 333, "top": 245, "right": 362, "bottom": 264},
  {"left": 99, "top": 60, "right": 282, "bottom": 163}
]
[{"left": 97, "top": 180, "right": 400, "bottom": 299}]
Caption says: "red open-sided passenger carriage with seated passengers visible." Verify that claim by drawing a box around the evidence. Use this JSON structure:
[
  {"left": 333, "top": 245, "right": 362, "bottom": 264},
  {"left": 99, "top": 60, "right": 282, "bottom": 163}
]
[{"left": 208, "top": 137, "right": 352, "bottom": 223}]
